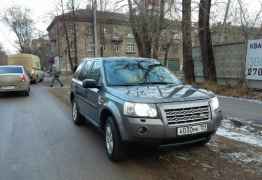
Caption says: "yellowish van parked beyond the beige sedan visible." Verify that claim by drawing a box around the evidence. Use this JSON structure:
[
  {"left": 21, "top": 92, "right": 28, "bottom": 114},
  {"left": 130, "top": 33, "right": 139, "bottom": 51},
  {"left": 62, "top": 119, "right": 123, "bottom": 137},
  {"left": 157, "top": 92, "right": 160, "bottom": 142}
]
[{"left": 7, "top": 53, "right": 44, "bottom": 83}]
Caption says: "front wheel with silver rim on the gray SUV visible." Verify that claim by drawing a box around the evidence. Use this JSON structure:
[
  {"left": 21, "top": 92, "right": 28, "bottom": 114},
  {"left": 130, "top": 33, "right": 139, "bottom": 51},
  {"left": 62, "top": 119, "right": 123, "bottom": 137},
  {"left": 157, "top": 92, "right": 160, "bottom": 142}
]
[{"left": 104, "top": 117, "right": 125, "bottom": 161}]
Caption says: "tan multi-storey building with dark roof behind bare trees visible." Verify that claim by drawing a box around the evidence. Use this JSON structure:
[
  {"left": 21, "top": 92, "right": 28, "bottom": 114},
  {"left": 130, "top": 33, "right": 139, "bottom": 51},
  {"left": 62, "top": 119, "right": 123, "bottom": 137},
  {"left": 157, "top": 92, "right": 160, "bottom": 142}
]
[{"left": 47, "top": 9, "right": 182, "bottom": 71}]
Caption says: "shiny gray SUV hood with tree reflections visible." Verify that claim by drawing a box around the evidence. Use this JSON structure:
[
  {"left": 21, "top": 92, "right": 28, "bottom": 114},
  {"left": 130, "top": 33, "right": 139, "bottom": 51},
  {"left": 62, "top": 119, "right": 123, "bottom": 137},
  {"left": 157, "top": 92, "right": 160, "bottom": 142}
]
[{"left": 108, "top": 85, "right": 214, "bottom": 103}]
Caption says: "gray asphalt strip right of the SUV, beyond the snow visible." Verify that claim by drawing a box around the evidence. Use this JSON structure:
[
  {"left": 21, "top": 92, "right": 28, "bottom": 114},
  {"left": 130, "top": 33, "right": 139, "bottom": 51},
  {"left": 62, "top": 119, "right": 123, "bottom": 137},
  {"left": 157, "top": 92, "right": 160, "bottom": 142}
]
[{"left": 219, "top": 97, "right": 262, "bottom": 125}]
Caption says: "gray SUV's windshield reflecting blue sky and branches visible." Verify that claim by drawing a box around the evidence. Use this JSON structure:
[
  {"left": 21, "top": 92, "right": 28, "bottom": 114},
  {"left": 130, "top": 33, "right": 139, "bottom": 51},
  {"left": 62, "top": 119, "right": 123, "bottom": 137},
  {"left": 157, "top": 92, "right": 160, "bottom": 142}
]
[{"left": 104, "top": 60, "right": 181, "bottom": 86}]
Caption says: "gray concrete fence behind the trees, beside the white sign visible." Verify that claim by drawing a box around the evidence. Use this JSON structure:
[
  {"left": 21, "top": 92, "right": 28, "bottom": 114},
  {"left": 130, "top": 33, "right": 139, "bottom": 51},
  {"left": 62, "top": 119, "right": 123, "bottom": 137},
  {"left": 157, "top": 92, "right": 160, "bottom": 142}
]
[{"left": 193, "top": 42, "right": 262, "bottom": 89}]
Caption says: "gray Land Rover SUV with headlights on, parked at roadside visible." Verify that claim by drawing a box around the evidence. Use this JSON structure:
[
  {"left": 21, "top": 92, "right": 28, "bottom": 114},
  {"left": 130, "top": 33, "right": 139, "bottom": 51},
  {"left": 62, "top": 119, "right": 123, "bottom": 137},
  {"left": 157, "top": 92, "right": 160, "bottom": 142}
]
[{"left": 70, "top": 57, "right": 222, "bottom": 161}]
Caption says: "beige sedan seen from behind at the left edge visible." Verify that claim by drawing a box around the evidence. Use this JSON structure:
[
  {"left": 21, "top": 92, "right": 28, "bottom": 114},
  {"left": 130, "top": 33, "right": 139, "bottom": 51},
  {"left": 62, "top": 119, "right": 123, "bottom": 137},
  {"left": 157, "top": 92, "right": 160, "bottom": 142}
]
[{"left": 0, "top": 65, "right": 30, "bottom": 96}]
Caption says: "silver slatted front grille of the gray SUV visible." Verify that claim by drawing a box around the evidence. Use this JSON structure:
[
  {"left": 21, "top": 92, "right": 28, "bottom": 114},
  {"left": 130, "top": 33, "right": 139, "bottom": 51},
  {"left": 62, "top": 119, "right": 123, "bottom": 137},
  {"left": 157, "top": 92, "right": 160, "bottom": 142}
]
[{"left": 165, "top": 106, "right": 210, "bottom": 125}]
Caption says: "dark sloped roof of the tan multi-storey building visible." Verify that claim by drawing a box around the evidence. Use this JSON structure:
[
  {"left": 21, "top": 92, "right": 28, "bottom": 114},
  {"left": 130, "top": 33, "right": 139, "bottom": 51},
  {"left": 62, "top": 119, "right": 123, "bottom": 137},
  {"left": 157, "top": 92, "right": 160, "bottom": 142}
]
[{"left": 47, "top": 9, "right": 128, "bottom": 31}]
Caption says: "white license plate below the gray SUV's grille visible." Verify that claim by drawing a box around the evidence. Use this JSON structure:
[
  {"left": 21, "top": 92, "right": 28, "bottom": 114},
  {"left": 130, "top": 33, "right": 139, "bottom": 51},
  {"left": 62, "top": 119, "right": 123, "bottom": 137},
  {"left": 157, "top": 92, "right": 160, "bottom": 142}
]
[{"left": 177, "top": 124, "right": 207, "bottom": 136}]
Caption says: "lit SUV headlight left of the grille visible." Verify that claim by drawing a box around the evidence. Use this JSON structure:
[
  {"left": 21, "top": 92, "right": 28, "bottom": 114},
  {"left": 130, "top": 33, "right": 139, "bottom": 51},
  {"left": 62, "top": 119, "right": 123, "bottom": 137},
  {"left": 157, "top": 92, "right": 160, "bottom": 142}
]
[{"left": 124, "top": 102, "right": 157, "bottom": 118}]
